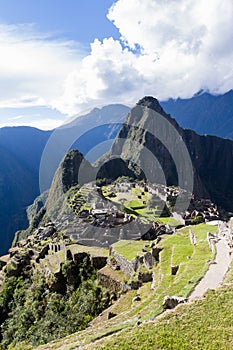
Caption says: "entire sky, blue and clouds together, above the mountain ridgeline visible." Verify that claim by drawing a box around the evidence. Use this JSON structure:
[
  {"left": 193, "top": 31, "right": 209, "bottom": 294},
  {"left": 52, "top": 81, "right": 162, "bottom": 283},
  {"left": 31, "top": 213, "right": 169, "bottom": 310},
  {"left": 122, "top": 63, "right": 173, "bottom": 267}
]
[{"left": 0, "top": 0, "right": 233, "bottom": 129}]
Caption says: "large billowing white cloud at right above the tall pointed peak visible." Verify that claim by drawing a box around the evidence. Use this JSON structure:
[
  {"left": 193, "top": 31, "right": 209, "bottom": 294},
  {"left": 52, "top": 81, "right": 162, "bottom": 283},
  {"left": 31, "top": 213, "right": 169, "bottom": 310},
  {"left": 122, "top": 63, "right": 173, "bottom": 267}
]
[{"left": 54, "top": 0, "right": 233, "bottom": 114}]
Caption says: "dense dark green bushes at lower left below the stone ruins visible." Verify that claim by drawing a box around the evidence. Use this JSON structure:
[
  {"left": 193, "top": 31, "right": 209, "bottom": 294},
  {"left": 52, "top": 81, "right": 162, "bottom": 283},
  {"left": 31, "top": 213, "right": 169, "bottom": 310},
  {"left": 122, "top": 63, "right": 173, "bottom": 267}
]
[{"left": 0, "top": 260, "right": 109, "bottom": 349}]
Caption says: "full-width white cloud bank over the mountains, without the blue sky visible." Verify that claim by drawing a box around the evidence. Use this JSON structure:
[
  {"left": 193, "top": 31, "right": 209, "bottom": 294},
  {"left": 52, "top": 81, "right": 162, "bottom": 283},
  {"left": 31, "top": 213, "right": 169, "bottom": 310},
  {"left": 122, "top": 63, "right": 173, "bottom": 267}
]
[{"left": 0, "top": 0, "right": 233, "bottom": 121}]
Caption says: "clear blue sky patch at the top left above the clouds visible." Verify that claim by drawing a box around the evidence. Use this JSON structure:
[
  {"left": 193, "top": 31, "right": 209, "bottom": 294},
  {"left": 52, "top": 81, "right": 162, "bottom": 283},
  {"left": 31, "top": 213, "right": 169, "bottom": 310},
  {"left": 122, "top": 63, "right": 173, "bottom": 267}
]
[{"left": 0, "top": 0, "right": 119, "bottom": 43}]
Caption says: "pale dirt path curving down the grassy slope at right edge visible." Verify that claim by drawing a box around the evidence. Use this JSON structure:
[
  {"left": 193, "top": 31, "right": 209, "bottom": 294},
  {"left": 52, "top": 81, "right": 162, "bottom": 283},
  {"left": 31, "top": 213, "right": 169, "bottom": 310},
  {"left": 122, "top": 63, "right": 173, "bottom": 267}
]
[{"left": 189, "top": 239, "right": 232, "bottom": 300}]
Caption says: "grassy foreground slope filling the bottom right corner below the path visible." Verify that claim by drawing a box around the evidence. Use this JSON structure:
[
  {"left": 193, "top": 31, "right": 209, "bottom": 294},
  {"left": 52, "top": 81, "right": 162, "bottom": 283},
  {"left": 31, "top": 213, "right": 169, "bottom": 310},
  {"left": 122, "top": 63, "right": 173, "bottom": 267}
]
[{"left": 93, "top": 285, "right": 233, "bottom": 350}]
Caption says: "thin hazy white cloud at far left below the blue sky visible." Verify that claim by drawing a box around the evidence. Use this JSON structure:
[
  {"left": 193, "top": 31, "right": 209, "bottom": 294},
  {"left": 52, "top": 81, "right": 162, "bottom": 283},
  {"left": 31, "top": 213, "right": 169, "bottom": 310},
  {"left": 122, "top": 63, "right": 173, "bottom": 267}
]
[{"left": 0, "top": 24, "right": 83, "bottom": 108}]
